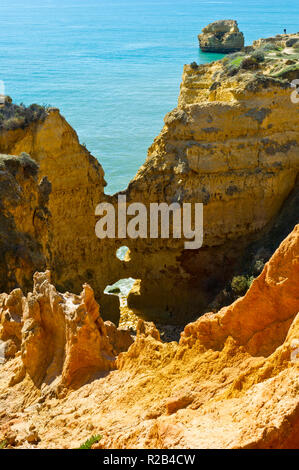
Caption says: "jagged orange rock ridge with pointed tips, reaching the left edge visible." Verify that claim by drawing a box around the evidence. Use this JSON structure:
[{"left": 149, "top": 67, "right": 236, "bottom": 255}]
[{"left": 0, "top": 271, "right": 119, "bottom": 393}]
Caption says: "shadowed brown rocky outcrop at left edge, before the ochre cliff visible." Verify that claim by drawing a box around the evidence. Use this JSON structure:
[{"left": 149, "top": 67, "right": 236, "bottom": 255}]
[{"left": 0, "top": 153, "right": 51, "bottom": 292}]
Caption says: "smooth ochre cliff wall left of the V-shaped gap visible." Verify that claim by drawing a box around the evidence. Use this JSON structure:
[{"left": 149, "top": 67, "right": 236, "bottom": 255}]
[{"left": 0, "top": 104, "right": 120, "bottom": 322}]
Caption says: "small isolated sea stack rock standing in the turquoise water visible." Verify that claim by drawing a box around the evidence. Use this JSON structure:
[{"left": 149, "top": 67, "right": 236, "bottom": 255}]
[{"left": 198, "top": 20, "right": 244, "bottom": 53}]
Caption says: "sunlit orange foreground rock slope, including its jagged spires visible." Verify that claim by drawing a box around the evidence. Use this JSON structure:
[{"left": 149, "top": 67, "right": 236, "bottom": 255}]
[{"left": 0, "top": 225, "right": 299, "bottom": 449}]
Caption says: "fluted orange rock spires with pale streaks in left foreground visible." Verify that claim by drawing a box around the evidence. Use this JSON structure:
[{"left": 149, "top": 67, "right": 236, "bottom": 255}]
[{"left": 21, "top": 272, "right": 115, "bottom": 387}]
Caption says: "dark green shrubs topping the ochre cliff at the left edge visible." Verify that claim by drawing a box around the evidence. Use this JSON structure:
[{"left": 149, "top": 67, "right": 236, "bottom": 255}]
[{"left": 0, "top": 97, "right": 47, "bottom": 131}]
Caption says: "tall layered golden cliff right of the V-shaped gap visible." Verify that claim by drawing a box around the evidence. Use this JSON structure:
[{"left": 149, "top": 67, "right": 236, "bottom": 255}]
[{"left": 116, "top": 36, "right": 299, "bottom": 322}]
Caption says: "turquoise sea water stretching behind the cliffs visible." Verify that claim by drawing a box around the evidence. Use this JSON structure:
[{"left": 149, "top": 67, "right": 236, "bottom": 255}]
[{"left": 0, "top": 0, "right": 299, "bottom": 193}]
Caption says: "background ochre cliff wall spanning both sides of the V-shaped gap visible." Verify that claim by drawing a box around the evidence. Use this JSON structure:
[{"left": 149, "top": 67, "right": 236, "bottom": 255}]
[{"left": 0, "top": 35, "right": 299, "bottom": 324}]
